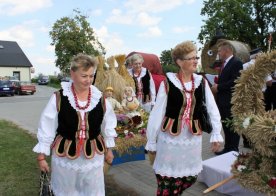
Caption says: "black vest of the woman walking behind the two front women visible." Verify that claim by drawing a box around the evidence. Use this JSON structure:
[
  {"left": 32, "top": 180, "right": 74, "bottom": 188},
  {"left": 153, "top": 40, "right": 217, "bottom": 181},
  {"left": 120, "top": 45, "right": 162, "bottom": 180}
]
[{"left": 133, "top": 70, "right": 151, "bottom": 103}]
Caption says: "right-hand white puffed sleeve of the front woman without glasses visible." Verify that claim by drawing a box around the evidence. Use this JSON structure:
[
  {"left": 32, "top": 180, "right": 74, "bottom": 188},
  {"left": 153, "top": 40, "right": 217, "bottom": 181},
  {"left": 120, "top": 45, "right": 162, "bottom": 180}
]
[{"left": 101, "top": 100, "right": 117, "bottom": 148}]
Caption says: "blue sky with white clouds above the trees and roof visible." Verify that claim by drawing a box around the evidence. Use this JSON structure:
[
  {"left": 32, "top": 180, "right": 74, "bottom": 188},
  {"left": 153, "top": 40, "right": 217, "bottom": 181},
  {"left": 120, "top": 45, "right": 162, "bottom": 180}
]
[{"left": 0, "top": 0, "right": 203, "bottom": 76}]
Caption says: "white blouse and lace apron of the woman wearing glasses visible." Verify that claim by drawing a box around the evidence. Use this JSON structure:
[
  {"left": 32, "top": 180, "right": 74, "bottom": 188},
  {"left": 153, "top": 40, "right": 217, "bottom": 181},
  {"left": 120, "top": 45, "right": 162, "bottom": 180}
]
[{"left": 145, "top": 73, "right": 223, "bottom": 177}]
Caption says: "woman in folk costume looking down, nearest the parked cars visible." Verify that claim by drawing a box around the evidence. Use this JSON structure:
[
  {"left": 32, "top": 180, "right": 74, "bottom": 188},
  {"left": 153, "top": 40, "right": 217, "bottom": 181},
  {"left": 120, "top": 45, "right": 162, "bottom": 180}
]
[{"left": 33, "top": 54, "right": 117, "bottom": 196}]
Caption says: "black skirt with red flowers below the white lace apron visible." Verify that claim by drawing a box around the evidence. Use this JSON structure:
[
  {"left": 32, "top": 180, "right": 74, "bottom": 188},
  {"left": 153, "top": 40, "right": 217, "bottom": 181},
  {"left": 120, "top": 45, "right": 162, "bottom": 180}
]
[{"left": 156, "top": 174, "right": 197, "bottom": 196}]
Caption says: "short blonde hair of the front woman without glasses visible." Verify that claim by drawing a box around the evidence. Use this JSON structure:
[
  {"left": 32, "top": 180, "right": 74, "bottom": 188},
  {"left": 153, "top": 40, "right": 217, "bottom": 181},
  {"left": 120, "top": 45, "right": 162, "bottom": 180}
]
[{"left": 70, "top": 53, "right": 99, "bottom": 72}]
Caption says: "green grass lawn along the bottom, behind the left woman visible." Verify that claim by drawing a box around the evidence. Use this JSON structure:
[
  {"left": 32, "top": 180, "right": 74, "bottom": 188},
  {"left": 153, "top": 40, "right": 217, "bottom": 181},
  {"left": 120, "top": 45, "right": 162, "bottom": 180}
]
[{"left": 0, "top": 120, "right": 137, "bottom": 196}]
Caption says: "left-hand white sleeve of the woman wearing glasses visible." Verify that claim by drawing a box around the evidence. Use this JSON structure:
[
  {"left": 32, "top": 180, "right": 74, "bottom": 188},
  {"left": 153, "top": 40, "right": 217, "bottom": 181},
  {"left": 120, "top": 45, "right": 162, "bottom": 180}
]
[{"left": 145, "top": 82, "right": 167, "bottom": 151}]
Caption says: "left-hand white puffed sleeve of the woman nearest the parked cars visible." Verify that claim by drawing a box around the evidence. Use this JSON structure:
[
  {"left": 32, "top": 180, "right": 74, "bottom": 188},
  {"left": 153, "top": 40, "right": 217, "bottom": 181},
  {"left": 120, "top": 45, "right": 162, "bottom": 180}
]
[{"left": 33, "top": 94, "right": 58, "bottom": 155}]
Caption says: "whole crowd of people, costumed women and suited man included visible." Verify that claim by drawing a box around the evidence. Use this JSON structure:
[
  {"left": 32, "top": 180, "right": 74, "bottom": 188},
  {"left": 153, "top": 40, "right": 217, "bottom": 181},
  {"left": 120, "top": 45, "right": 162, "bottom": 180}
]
[{"left": 33, "top": 41, "right": 276, "bottom": 196}]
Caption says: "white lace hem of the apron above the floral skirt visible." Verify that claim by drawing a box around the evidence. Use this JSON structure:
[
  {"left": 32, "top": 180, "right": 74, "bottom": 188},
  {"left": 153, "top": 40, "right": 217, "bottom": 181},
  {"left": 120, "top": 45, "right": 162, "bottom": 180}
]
[{"left": 154, "top": 164, "right": 203, "bottom": 178}]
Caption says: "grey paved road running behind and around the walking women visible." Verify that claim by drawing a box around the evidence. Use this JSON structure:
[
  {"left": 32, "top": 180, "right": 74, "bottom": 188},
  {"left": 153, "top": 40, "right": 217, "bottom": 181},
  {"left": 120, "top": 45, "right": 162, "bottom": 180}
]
[{"left": 0, "top": 85, "right": 227, "bottom": 196}]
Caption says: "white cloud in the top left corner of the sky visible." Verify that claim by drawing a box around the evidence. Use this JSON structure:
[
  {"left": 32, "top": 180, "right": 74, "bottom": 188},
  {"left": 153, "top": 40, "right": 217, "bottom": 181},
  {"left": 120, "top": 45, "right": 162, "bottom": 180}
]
[{"left": 0, "top": 0, "right": 53, "bottom": 16}]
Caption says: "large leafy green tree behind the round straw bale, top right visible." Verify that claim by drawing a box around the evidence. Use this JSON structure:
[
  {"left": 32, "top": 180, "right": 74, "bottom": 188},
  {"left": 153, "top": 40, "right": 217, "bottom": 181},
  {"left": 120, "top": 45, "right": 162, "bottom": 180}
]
[{"left": 198, "top": 0, "right": 276, "bottom": 51}]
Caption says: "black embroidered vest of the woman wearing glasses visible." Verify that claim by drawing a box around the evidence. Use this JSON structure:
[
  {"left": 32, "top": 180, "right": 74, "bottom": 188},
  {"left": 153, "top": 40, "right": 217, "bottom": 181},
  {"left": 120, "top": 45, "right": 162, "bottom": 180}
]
[{"left": 162, "top": 78, "right": 202, "bottom": 136}]
